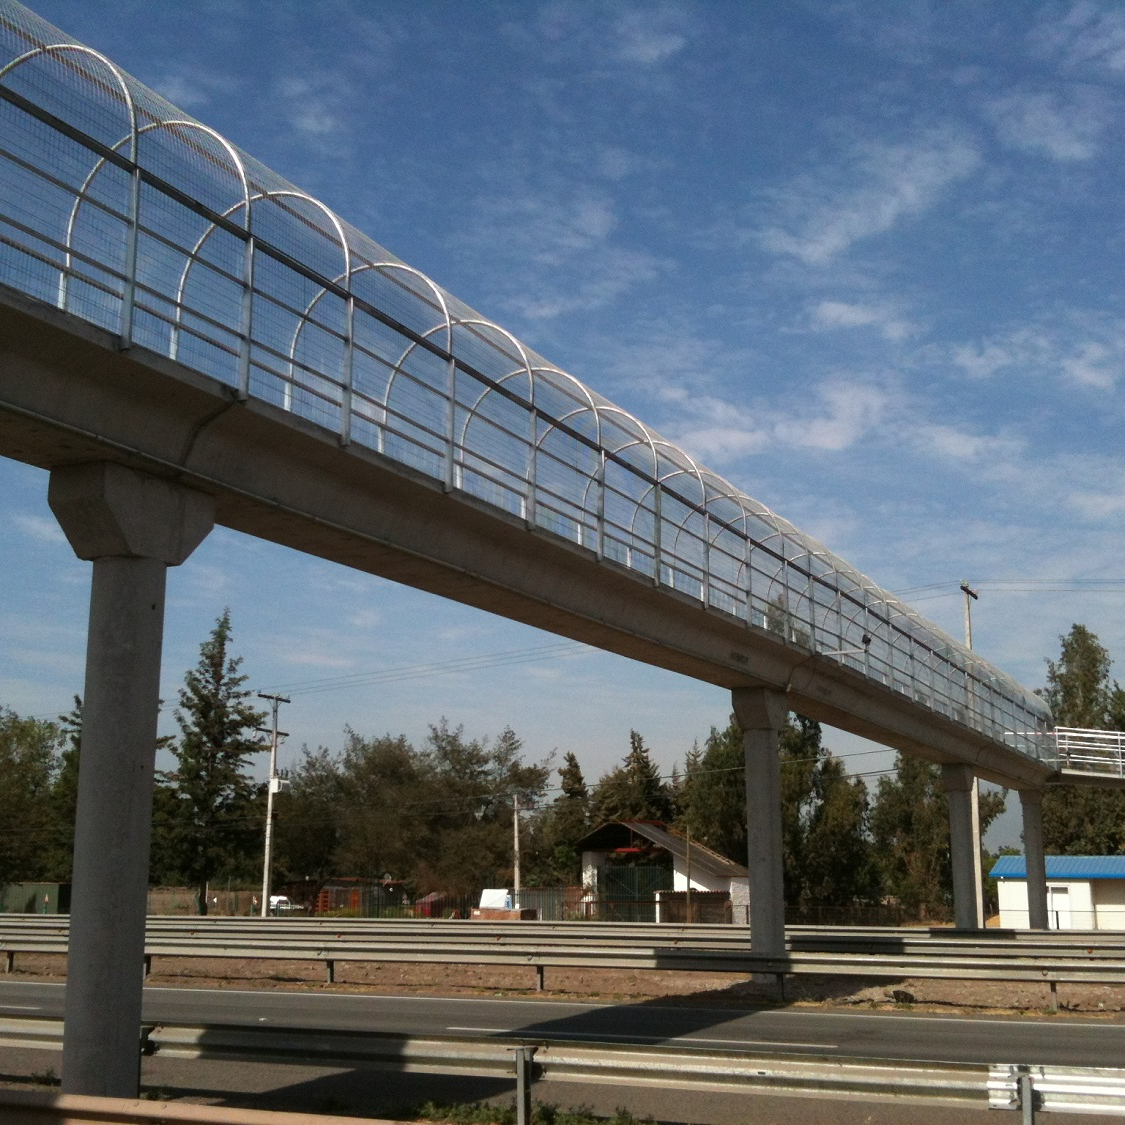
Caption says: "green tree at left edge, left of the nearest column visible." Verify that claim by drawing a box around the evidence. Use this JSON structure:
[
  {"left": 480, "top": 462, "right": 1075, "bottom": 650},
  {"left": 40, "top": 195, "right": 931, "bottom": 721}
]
[{"left": 0, "top": 707, "right": 62, "bottom": 887}]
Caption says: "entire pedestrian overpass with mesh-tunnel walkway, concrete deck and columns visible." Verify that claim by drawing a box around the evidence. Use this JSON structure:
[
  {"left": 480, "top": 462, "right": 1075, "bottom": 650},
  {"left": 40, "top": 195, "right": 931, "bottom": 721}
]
[{"left": 0, "top": 0, "right": 1121, "bottom": 1095}]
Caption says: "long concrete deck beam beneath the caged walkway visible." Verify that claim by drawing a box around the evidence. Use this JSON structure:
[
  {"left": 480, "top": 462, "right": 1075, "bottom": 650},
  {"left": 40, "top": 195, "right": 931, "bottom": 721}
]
[{"left": 0, "top": 290, "right": 1052, "bottom": 788}]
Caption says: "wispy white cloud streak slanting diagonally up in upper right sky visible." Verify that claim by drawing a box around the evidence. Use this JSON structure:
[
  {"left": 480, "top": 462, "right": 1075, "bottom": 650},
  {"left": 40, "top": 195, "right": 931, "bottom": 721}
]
[{"left": 758, "top": 131, "right": 980, "bottom": 266}]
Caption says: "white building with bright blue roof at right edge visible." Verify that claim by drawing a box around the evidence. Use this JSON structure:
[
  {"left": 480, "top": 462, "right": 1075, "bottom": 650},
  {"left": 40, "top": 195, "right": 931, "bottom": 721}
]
[{"left": 990, "top": 855, "right": 1125, "bottom": 930}]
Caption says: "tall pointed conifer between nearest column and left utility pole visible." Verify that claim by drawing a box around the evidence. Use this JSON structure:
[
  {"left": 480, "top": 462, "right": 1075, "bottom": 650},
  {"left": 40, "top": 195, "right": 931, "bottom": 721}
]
[{"left": 160, "top": 610, "right": 266, "bottom": 915}]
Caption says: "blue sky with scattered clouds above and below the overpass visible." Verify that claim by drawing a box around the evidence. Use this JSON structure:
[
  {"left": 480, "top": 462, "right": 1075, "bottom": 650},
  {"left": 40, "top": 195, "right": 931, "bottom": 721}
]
[{"left": 0, "top": 0, "right": 1125, "bottom": 839}]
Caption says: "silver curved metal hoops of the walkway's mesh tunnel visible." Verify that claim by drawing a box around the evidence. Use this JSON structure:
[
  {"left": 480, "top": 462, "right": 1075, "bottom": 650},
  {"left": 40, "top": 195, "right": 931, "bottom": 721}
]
[{"left": 0, "top": 10, "right": 1049, "bottom": 739}]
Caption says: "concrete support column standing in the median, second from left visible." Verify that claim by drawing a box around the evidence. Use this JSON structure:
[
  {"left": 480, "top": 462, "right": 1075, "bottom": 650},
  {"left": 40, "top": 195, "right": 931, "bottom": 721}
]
[{"left": 731, "top": 687, "right": 789, "bottom": 956}]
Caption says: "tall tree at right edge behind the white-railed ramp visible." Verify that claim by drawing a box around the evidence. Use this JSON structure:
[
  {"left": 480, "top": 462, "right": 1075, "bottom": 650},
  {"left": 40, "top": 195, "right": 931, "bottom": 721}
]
[{"left": 1043, "top": 624, "right": 1125, "bottom": 855}]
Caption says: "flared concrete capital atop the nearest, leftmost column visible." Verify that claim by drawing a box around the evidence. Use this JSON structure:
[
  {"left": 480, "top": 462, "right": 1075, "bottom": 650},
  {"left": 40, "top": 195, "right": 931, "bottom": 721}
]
[{"left": 47, "top": 461, "right": 215, "bottom": 566}]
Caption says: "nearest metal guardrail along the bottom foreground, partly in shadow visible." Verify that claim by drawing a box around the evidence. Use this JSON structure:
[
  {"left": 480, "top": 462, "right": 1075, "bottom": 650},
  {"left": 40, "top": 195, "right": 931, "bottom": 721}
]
[{"left": 0, "top": 1017, "right": 1125, "bottom": 1122}]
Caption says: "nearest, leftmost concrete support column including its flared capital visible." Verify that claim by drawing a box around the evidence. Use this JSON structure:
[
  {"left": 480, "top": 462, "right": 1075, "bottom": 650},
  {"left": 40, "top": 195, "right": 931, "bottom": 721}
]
[{"left": 48, "top": 462, "right": 214, "bottom": 1098}]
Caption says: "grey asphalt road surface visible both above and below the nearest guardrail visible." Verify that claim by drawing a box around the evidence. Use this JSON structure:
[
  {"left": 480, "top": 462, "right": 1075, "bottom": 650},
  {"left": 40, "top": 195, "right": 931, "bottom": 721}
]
[{"left": 0, "top": 981, "right": 1125, "bottom": 1125}]
